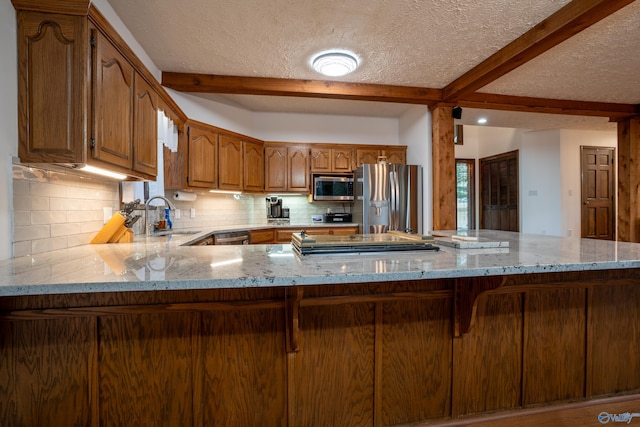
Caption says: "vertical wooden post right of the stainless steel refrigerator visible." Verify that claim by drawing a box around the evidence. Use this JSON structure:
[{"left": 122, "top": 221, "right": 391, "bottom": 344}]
[{"left": 431, "top": 104, "right": 456, "bottom": 230}]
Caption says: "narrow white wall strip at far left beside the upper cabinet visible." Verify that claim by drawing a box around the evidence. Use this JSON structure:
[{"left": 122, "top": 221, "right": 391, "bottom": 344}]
[{"left": 0, "top": 0, "right": 18, "bottom": 259}]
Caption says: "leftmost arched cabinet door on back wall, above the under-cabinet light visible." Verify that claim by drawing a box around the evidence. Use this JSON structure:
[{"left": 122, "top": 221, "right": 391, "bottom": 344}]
[{"left": 187, "top": 127, "right": 218, "bottom": 188}]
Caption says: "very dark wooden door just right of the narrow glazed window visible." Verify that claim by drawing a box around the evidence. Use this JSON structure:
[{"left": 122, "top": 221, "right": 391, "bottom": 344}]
[{"left": 480, "top": 151, "right": 520, "bottom": 231}]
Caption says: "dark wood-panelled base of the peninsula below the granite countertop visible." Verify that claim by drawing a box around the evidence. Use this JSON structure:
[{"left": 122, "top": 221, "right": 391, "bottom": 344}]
[{"left": 0, "top": 269, "right": 640, "bottom": 426}]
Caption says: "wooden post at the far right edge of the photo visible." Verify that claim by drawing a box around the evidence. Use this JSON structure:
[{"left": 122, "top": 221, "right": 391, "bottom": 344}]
[{"left": 616, "top": 117, "right": 640, "bottom": 242}]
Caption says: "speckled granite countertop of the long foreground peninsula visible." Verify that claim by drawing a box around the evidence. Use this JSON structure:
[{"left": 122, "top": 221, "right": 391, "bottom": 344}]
[{"left": 0, "top": 231, "right": 640, "bottom": 297}]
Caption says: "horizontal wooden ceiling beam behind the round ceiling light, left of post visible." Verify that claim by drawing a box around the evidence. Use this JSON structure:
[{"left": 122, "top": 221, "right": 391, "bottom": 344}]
[{"left": 162, "top": 72, "right": 442, "bottom": 106}]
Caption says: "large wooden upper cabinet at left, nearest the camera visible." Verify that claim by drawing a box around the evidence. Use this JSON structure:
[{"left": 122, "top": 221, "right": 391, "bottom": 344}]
[{"left": 16, "top": 8, "right": 158, "bottom": 179}]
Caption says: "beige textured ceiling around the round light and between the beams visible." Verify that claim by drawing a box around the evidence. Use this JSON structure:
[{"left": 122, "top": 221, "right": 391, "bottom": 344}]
[{"left": 109, "top": 0, "right": 640, "bottom": 129}]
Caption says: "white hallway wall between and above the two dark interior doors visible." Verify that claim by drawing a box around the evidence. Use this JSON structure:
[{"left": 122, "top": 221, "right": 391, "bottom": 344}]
[{"left": 455, "top": 126, "right": 617, "bottom": 237}]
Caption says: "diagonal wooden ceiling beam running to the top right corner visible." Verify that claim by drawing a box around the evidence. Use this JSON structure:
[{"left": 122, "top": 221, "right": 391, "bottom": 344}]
[{"left": 442, "top": 0, "right": 633, "bottom": 102}]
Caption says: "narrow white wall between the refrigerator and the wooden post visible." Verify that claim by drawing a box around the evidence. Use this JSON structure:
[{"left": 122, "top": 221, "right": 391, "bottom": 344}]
[{"left": 400, "top": 107, "right": 433, "bottom": 233}]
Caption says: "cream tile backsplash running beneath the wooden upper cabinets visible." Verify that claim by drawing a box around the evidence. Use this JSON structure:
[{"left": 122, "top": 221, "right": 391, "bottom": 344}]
[{"left": 12, "top": 164, "right": 351, "bottom": 257}]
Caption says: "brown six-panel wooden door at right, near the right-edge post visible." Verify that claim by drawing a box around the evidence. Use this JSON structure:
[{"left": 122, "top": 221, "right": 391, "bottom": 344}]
[{"left": 580, "top": 147, "right": 615, "bottom": 240}]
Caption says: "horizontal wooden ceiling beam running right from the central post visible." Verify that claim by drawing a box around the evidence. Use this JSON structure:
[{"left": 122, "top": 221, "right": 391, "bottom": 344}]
[{"left": 456, "top": 92, "right": 640, "bottom": 120}]
